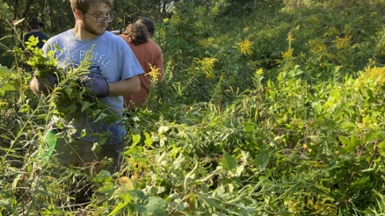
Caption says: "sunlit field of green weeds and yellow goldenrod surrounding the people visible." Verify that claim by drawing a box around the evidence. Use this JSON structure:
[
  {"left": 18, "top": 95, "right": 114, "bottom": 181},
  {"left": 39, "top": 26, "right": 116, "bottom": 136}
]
[{"left": 0, "top": 0, "right": 385, "bottom": 216}]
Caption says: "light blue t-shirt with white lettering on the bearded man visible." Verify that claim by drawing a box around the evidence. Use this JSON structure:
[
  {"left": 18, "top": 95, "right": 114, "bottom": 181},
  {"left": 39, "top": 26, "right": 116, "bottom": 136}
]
[{"left": 43, "top": 29, "right": 143, "bottom": 144}]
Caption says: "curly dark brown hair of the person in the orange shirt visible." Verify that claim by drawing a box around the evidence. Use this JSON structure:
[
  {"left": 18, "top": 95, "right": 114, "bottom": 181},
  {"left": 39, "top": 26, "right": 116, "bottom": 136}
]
[{"left": 123, "top": 22, "right": 149, "bottom": 45}]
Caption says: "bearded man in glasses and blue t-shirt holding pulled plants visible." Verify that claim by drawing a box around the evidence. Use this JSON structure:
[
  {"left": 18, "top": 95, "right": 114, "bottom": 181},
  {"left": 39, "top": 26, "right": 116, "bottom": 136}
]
[{"left": 30, "top": 0, "right": 143, "bottom": 172}]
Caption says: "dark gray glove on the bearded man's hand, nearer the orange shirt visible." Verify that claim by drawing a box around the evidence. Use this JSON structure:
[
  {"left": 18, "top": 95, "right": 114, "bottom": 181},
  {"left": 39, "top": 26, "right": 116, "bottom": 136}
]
[{"left": 80, "top": 73, "right": 110, "bottom": 98}]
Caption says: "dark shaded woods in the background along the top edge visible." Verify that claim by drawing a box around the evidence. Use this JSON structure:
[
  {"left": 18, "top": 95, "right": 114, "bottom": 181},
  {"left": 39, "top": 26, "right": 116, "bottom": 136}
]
[{"left": 0, "top": 0, "right": 258, "bottom": 66}]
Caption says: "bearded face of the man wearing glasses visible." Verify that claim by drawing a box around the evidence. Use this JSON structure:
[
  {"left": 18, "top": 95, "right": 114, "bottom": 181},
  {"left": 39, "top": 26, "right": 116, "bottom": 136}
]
[{"left": 83, "top": 3, "right": 111, "bottom": 35}]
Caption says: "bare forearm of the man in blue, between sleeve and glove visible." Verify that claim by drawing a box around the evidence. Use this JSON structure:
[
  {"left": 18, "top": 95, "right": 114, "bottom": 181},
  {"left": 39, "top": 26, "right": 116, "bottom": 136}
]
[{"left": 108, "top": 76, "right": 140, "bottom": 96}]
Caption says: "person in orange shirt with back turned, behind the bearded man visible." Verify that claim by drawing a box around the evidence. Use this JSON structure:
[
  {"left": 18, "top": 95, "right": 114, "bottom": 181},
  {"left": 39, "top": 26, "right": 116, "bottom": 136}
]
[{"left": 120, "top": 17, "right": 164, "bottom": 110}]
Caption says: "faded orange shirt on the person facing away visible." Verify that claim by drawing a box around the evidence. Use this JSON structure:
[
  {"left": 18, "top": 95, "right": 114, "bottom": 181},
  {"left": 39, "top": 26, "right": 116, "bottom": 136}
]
[{"left": 120, "top": 35, "right": 164, "bottom": 109}]
